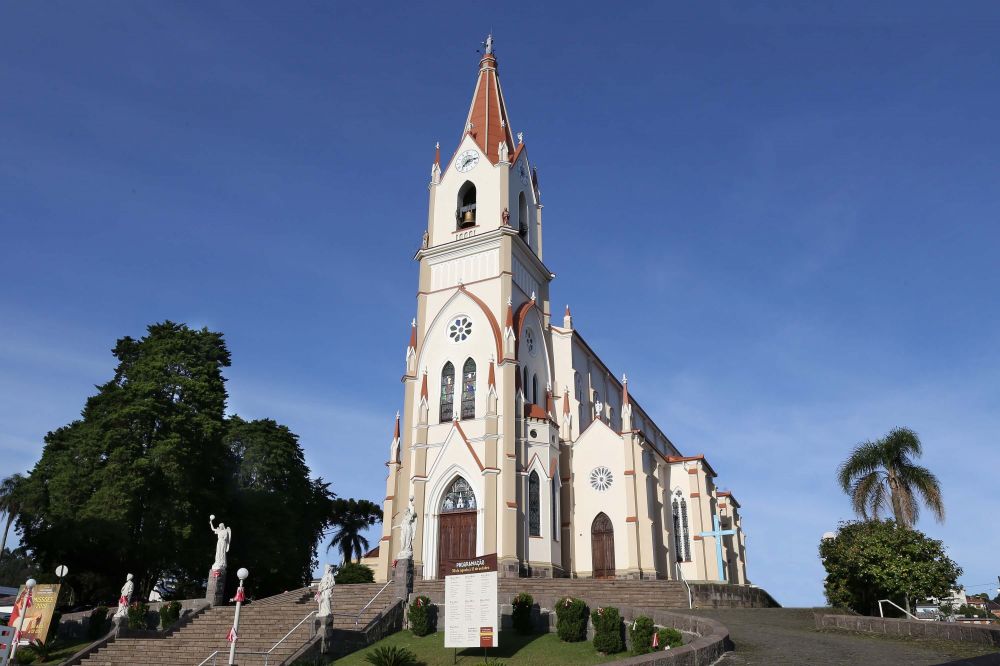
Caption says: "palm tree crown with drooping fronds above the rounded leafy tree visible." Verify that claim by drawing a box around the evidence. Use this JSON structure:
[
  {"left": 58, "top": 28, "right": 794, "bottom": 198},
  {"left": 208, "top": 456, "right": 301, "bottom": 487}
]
[{"left": 837, "top": 428, "right": 944, "bottom": 527}]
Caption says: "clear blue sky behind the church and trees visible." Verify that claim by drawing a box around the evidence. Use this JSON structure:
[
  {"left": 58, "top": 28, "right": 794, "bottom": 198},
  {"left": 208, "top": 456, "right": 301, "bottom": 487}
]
[{"left": 0, "top": 0, "right": 1000, "bottom": 605}]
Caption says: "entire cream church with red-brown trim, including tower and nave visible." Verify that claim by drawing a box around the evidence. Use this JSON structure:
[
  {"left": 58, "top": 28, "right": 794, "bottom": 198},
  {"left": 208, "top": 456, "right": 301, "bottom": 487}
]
[{"left": 376, "top": 45, "right": 747, "bottom": 584}]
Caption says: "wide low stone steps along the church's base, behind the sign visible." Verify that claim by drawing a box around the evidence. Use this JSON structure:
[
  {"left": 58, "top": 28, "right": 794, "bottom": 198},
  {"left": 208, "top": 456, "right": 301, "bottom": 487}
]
[{"left": 411, "top": 578, "right": 688, "bottom": 609}]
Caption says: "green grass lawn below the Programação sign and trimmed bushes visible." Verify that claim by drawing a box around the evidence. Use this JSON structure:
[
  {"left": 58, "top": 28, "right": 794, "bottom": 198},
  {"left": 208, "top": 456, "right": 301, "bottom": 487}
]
[{"left": 333, "top": 631, "right": 628, "bottom": 666}]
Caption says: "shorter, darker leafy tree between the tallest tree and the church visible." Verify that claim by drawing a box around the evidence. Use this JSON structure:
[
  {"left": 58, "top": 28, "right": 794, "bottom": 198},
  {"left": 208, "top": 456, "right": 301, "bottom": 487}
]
[{"left": 224, "top": 416, "right": 335, "bottom": 595}]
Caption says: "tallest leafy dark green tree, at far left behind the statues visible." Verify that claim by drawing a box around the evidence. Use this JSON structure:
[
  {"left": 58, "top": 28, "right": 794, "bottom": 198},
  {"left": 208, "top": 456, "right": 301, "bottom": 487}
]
[{"left": 19, "top": 321, "right": 230, "bottom": 599}]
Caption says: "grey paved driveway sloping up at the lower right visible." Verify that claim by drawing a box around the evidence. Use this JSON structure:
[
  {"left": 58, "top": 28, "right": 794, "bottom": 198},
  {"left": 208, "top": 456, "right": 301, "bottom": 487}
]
[{"left": 690, "top": 608, "right": 1000, "bottom": 666}]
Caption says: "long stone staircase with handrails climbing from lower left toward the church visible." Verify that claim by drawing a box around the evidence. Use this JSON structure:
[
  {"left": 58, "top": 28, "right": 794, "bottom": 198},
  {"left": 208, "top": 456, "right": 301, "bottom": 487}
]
[{"left": 79, "top": 583, "right": 395, "bottom": 666}]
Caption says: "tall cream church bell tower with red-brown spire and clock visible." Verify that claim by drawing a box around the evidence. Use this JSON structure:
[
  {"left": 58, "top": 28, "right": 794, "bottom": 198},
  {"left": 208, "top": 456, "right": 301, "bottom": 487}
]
[{"left": 376, "top": 37, "right": 562, "bottom": 580}]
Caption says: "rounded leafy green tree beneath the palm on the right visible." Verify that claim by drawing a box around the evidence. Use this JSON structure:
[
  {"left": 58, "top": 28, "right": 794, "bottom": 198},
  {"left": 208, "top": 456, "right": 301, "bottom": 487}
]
[{"left": 819, "top": 520, "right": 962, "bottom": 615}]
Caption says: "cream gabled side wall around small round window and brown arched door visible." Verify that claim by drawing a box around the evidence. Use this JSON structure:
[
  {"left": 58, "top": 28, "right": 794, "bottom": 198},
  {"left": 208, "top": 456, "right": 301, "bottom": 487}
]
[{"left": 572, "top": 422, "right": 628, "bottom": 575}]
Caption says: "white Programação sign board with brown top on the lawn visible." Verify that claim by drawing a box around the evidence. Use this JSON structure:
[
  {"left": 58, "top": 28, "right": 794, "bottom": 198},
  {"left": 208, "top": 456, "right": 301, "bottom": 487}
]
[{"left": 444, "top": 553, "right": 500, "bottom": 648}]
